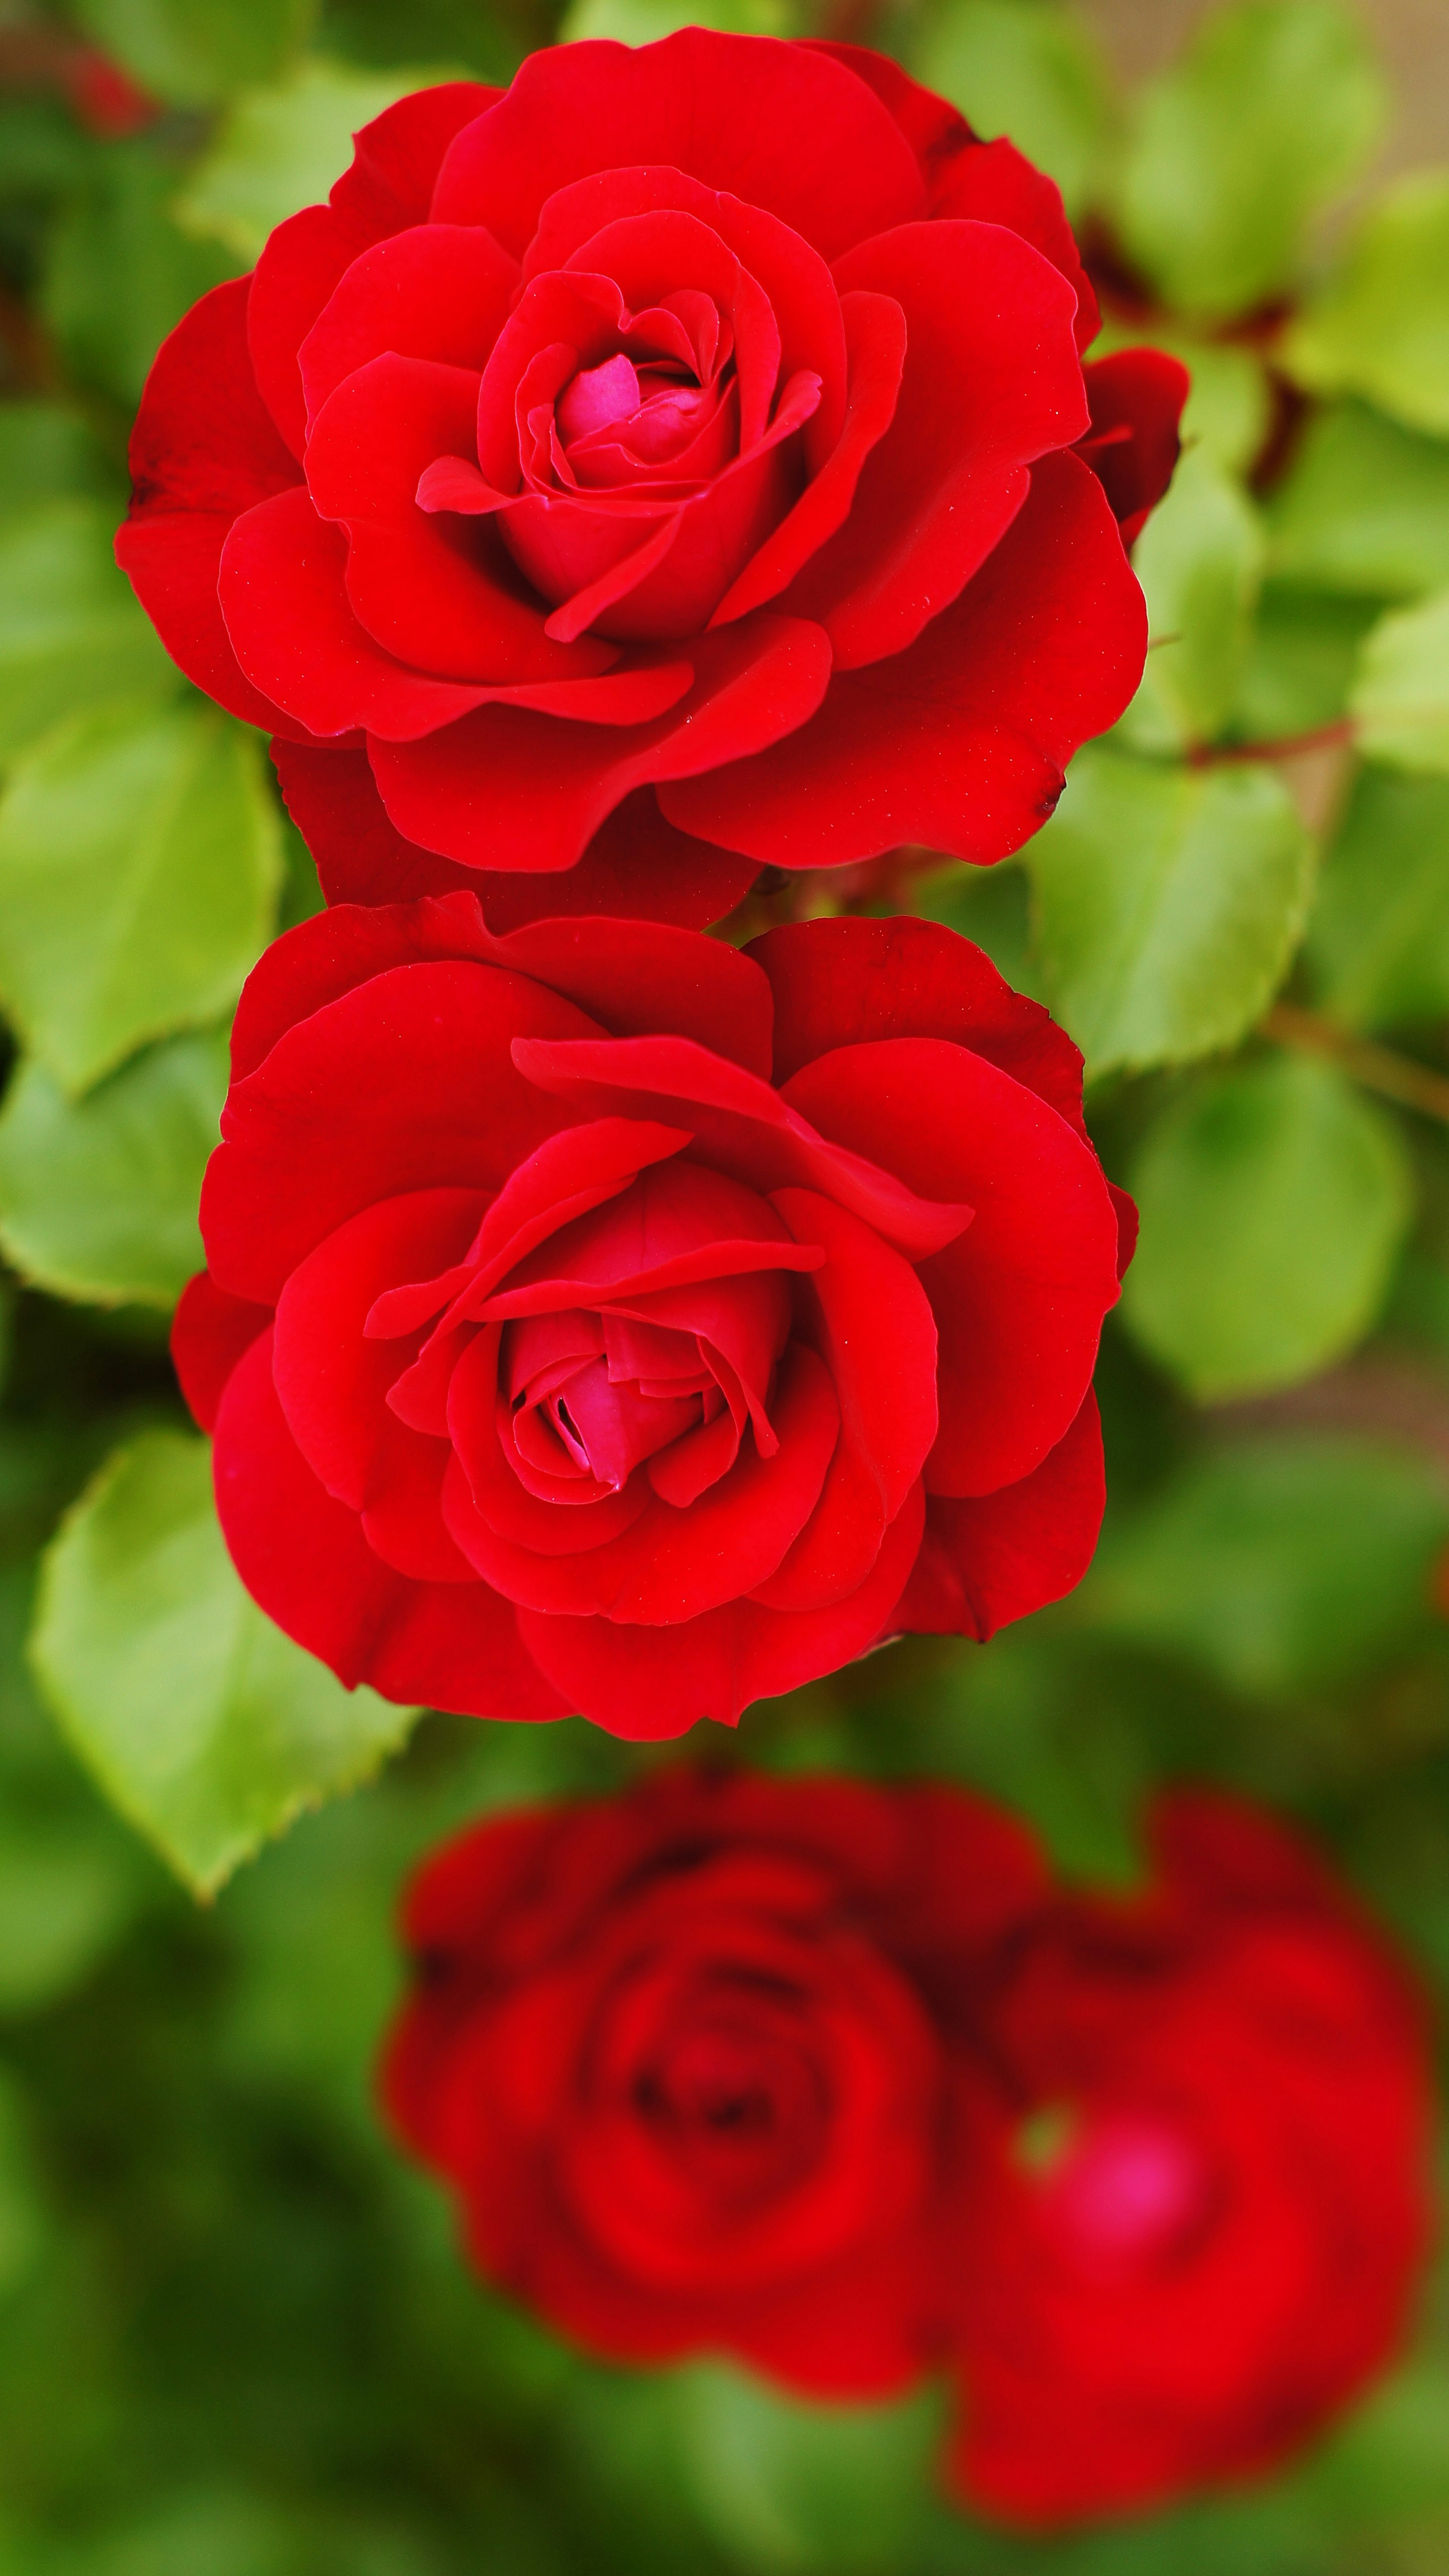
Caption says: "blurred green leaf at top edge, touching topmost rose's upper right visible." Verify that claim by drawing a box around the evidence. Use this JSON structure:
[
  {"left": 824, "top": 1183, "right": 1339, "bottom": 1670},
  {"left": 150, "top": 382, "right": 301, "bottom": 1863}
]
[{"left": 910, "top": 0, "right": 1106, "bottom": 221}]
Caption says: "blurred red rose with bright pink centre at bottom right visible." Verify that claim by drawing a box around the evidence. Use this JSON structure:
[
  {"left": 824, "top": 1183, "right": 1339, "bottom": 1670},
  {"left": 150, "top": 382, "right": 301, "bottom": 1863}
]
[{"left": 954, "top": 1795, "right": 1431, "bottom": 2524}]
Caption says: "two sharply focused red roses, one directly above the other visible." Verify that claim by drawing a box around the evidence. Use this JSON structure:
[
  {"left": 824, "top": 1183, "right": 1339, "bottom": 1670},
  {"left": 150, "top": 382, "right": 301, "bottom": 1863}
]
[{"left": 118, "top": 28, "right": 1186, "bottom": 1736}]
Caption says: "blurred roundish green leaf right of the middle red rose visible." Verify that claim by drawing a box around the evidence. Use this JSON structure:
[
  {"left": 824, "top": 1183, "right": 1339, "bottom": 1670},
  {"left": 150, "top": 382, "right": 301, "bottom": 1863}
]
[{"left": 1121, "top": 1051, "right": 1413, "bottom": 1404}]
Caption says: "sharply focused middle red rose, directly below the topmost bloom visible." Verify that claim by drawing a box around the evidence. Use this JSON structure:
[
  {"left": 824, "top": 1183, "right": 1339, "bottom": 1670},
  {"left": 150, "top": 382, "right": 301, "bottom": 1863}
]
[{"left": 173, "top": 894, "right": 1119, "bottom": 1736}]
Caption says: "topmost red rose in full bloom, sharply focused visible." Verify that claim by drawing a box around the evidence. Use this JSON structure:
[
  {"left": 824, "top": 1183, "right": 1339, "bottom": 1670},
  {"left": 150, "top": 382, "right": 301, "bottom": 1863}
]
[{"left": 118, "top": 28, "right": 1186, "bottom": 927}]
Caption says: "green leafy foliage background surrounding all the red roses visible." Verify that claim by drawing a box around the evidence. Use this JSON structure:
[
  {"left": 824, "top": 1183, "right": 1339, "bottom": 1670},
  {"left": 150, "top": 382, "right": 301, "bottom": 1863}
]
[{"left": 0, "top": 0, "right": 1449, "bottom": 2576}]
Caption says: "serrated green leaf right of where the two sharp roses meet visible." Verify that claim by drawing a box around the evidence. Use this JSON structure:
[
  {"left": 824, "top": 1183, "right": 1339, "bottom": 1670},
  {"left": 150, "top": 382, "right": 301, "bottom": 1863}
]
[{"left": 1029, "top": 750, "right": 1312, "bottom": 1074}]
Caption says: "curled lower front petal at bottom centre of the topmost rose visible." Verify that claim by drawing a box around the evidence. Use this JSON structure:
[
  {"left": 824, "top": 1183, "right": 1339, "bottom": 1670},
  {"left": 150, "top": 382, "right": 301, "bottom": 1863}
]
[{"left": 371, "top": 613, "right": 830, "bottom": 873}]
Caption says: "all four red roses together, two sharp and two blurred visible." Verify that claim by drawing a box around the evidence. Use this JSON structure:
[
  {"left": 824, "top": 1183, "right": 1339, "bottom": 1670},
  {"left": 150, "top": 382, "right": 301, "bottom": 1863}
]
[{"left": 118, "top": 28, "right": 1426, "bottom": 2524}]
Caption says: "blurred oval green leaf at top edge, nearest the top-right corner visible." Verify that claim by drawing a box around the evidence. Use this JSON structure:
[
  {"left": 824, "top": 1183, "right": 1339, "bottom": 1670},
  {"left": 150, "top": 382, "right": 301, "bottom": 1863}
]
[{"left": 1117, "top": 0, "right": 1387, "bottom": 317}]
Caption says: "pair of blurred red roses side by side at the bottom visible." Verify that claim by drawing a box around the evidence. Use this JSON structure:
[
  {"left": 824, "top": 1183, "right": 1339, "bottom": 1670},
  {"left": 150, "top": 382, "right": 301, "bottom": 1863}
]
[{"left": 384, "top": 1772, "right": 1431, "bottom": 2527}]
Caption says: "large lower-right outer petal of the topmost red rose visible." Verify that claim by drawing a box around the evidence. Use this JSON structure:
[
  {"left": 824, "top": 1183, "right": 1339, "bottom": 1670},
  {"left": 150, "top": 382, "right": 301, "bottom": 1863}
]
[{"left": 660, "top": 456, "right": 1148, "bottom": 868}]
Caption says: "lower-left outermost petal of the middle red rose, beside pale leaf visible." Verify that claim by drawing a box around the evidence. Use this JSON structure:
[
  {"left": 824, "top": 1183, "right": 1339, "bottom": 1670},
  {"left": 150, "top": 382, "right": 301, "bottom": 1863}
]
[{"left": 214, "top": 1334, "right": 567, "bottom": 1718}]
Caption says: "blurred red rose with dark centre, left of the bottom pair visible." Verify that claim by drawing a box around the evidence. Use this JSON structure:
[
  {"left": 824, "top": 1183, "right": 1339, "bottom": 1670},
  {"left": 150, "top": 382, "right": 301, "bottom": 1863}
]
[{"left": 384, "top": 1772, "right": 1041, "bottom": 2398}]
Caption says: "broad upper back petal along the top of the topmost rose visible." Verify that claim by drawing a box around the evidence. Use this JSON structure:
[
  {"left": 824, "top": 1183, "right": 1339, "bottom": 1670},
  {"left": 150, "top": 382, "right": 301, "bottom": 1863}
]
[{"left": 433, "top": 28, "right": 926, "bottom": 260}]
